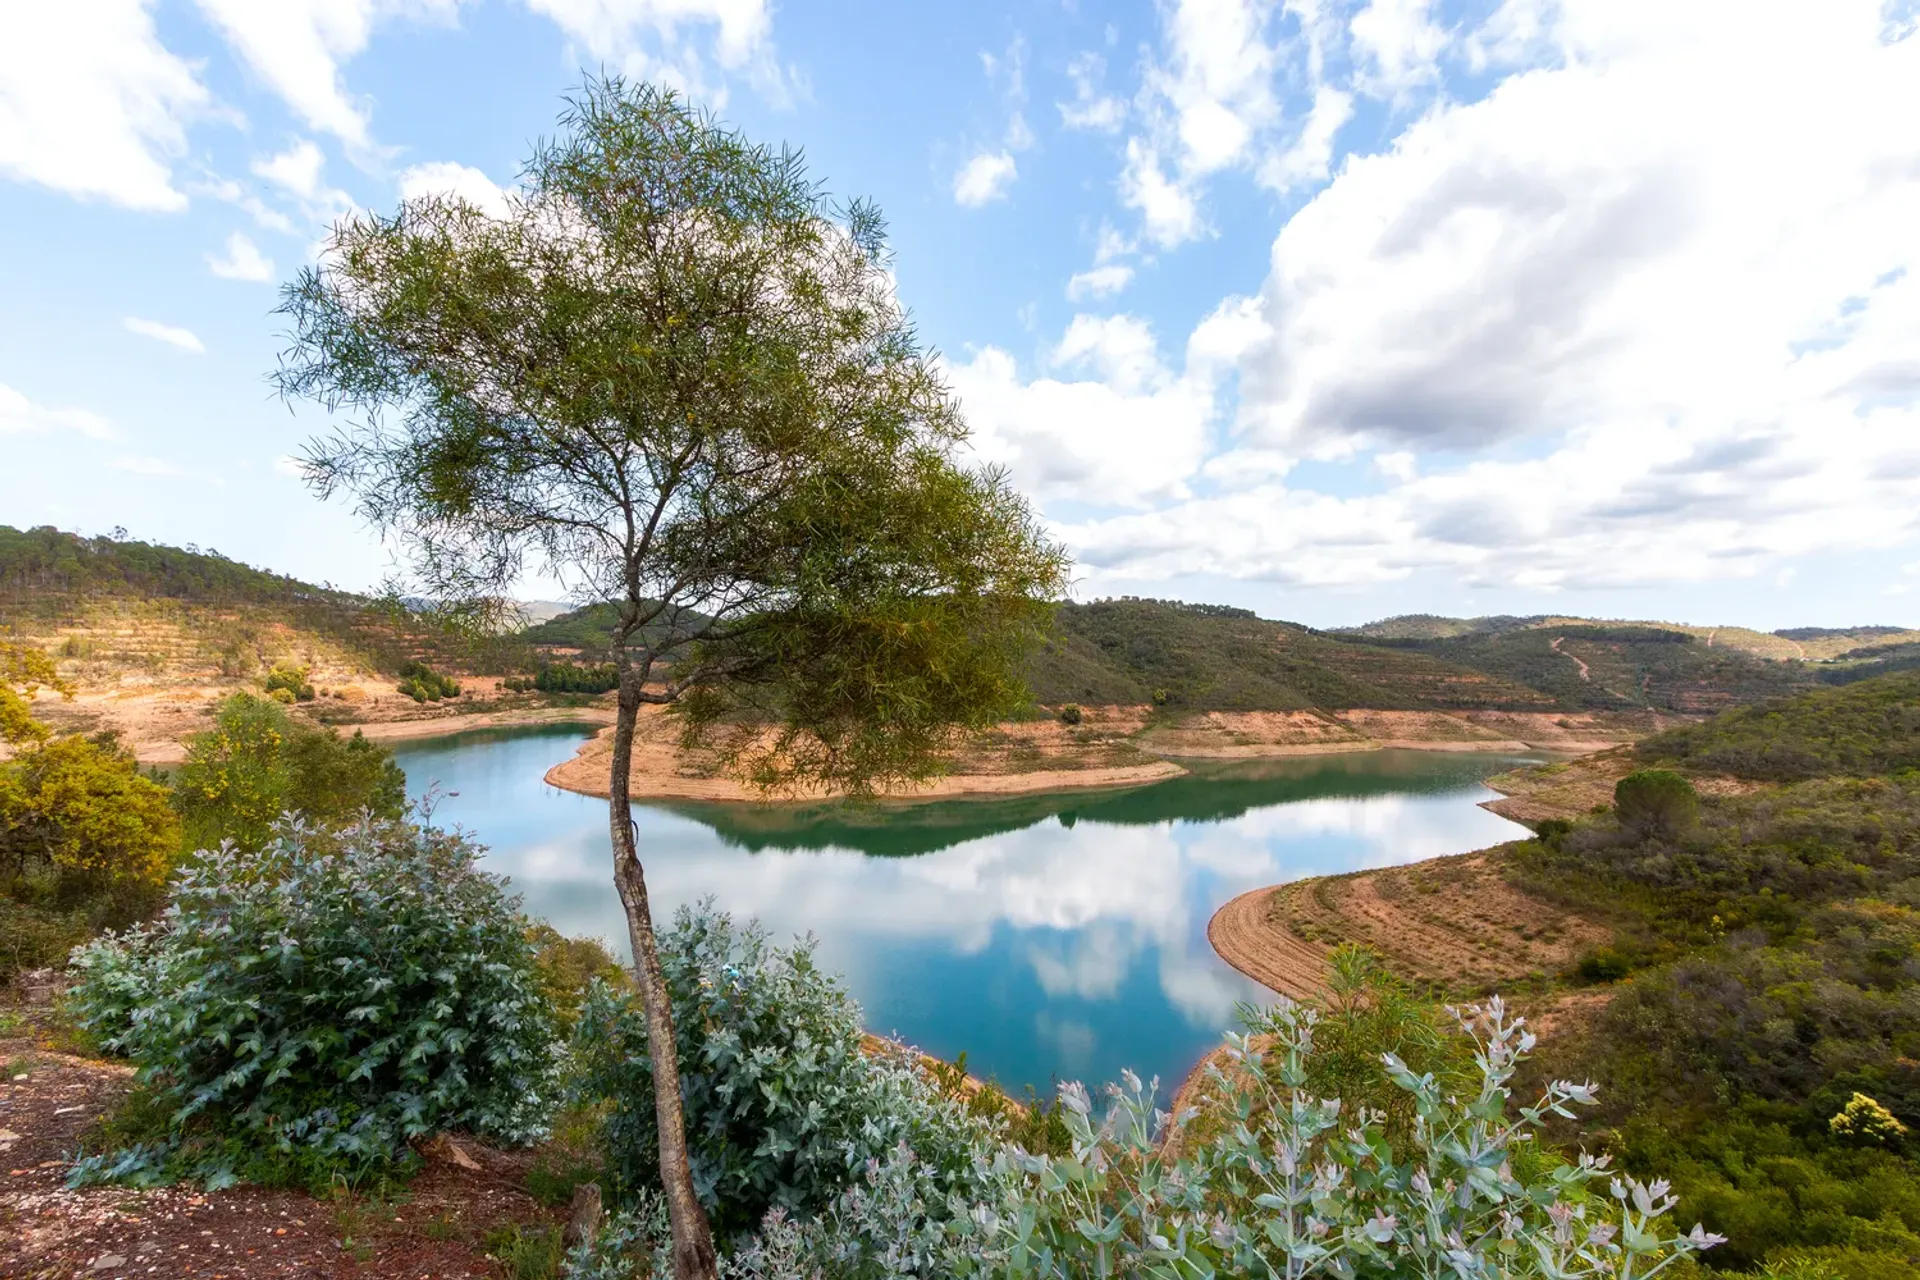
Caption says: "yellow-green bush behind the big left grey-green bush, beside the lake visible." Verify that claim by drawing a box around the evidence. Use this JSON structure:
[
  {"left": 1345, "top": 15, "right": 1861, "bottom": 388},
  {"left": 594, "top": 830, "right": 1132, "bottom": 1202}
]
[{"left": 173, "top": 693, "right": 407, "bottom": 850}]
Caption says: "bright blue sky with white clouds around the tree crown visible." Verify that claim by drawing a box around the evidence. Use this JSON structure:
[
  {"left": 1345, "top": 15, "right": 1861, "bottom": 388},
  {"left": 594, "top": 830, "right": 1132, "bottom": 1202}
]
[{"left": 0, "top": 0, "right": 1920, "bottom": 629}]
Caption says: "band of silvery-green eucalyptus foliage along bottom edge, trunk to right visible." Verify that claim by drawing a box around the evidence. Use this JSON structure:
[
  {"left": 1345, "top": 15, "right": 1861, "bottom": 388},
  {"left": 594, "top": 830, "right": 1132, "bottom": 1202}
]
[{"left": 622, "top": 1002, "right": 1716, "bottom": 1280}]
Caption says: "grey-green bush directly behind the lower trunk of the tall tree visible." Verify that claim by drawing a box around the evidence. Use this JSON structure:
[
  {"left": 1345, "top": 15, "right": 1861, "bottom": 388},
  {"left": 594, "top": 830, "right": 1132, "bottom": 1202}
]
[{"left": 574, "top": 908, "right": 993, "bottom": 1234}]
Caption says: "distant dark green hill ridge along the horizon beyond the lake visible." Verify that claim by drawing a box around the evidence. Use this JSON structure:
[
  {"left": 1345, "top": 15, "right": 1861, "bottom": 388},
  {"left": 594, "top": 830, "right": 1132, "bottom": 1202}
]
[{"left": 0, "top": 526, "right": 1896, "bottom": 714}]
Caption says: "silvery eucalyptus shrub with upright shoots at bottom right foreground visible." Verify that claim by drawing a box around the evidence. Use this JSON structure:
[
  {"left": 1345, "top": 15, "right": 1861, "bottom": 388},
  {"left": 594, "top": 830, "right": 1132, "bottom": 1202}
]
[{"left": 954, "top": 998, "right": 1720, "bottom": 1280}]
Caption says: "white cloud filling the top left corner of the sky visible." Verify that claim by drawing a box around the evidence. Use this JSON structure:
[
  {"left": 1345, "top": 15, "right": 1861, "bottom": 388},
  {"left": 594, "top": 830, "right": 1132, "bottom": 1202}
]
[{"left": 0, "top": 0, "right": 209, "bottom": 211}]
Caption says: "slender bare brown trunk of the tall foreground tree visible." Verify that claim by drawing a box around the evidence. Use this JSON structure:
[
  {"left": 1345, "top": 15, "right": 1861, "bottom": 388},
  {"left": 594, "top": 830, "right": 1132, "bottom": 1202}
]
[{"left": 607, "top": 664, "right": 720, "bottom": 1280}]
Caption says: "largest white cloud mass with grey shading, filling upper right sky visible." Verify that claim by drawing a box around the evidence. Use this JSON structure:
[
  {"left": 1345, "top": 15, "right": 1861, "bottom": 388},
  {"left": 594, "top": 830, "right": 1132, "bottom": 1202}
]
[{"left": 1062, "top": 0, "right": 1920, "bottom": 589}]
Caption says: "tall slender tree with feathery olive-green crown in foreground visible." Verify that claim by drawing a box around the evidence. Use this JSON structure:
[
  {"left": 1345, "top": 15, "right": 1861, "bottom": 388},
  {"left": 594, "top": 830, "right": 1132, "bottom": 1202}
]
[{"left": 276, "top": 79, "right": 1066, "bottom": 1278}]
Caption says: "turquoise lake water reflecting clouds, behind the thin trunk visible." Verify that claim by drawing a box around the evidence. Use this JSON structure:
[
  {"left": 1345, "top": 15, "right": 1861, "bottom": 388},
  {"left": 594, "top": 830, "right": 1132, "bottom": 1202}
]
[{"left": 397, "top": 727, "right": 1523, "bottom": 1092}]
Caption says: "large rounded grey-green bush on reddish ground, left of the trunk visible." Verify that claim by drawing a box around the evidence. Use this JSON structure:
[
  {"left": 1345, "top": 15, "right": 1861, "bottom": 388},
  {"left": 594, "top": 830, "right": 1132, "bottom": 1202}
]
[{"left": 71, "top": 821, "right": 553, "bottom": 1186}]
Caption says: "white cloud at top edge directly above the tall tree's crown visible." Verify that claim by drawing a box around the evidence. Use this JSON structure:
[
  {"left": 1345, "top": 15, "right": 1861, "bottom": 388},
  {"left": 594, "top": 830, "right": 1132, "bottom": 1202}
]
[{"left": 526, "top": 0, "right": 793, "bottom": 107}]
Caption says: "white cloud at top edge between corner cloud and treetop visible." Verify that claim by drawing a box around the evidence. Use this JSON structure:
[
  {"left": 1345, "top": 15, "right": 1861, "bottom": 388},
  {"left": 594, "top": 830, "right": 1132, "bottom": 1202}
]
[{"left": 198, "top": 0, "right": 461, "bottom": 148}]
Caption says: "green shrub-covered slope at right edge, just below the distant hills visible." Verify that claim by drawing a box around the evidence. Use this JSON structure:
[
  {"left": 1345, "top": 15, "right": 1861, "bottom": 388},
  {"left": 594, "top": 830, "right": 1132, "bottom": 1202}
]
[{"left": 1634, "top": 672, "right": 1920, "bottom": 781}]
